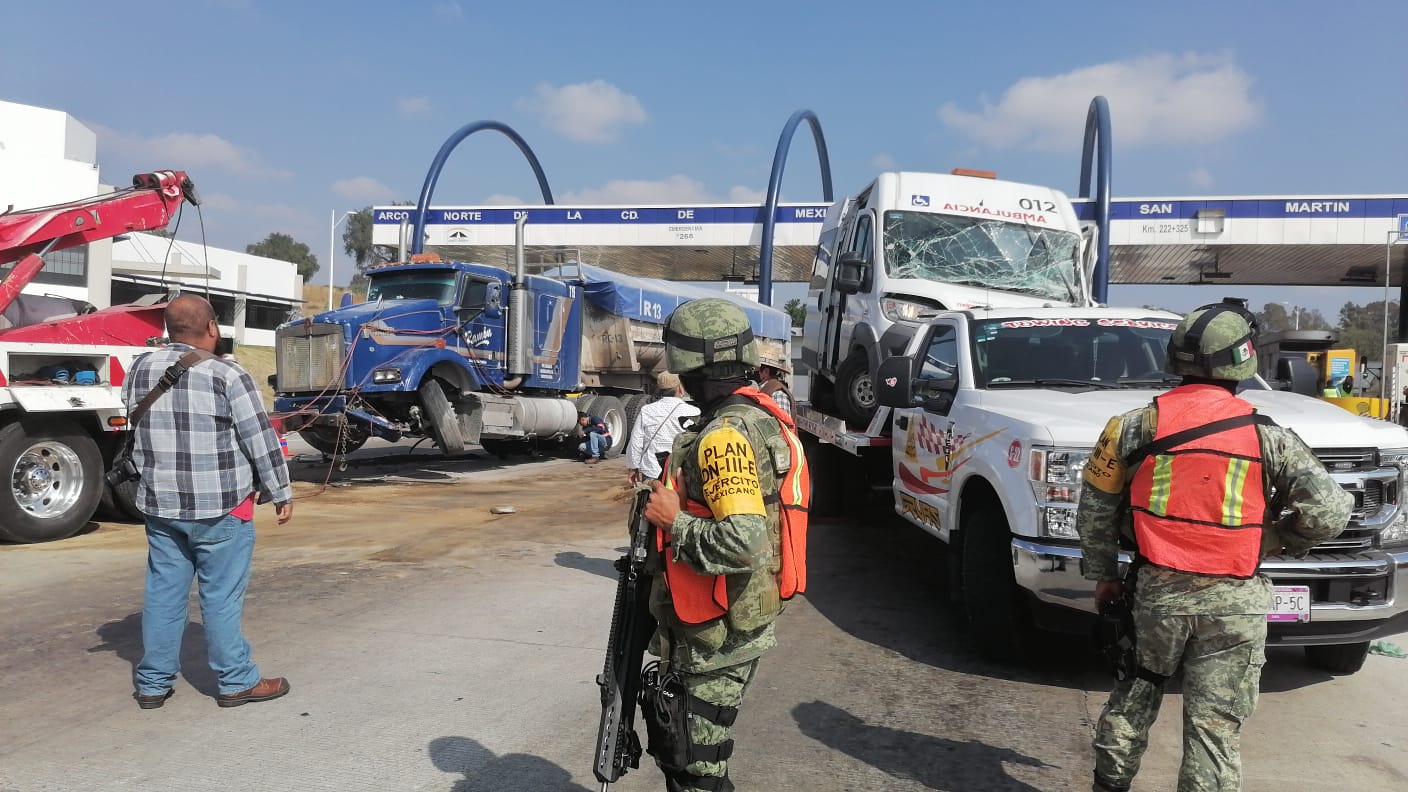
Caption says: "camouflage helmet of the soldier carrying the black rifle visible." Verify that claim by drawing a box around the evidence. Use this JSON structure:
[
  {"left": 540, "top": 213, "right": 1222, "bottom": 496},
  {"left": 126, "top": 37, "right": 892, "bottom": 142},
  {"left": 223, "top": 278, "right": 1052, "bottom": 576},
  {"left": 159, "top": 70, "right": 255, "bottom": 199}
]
[{"left": 665, "top": 297, "right": 759, "bottom": 376}]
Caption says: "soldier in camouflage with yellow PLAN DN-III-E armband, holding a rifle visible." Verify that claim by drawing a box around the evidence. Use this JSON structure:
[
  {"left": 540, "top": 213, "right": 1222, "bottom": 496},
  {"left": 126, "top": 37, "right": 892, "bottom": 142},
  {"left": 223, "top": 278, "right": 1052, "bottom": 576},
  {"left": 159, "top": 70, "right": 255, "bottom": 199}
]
[{"left": 645, "top": 299, "right": 790, "bottom": 792}]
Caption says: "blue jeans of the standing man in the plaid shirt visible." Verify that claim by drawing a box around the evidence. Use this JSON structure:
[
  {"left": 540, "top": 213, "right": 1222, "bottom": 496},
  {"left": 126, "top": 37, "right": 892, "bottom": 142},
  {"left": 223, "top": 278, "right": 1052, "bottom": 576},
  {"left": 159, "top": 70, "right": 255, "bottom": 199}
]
[{"left": 137, "top": 514, "right": 259, "bottom": 696}]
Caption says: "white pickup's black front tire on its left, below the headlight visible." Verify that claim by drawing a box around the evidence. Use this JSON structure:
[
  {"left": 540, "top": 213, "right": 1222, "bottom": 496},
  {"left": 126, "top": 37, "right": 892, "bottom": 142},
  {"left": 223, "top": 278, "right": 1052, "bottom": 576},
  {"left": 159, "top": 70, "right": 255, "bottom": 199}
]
[{"left": 960, "top": 503, "right": 1032, "bottom": 662}]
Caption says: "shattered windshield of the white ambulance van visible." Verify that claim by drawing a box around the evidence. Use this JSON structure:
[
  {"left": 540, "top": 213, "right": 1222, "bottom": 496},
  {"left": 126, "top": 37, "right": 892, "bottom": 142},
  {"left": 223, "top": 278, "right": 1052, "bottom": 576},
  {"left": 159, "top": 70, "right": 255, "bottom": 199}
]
[{"left": 884, "top": 211, "right": 1080, "bottom": 303}]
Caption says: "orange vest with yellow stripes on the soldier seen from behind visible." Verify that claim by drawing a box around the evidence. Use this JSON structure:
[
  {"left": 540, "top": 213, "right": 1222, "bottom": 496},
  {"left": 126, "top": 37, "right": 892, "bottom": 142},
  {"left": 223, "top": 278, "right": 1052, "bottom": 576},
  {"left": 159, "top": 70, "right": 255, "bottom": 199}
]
[{"left": 1129, "top": 385, "right": 1269, "bottom": 578}]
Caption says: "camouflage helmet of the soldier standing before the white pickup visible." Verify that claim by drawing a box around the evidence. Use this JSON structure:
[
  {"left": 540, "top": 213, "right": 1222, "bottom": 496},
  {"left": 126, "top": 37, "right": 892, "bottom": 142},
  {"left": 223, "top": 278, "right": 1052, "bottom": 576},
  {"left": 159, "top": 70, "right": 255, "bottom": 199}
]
[{"left": 1167, "top": 303, "right": 1256, "bottom": 380}]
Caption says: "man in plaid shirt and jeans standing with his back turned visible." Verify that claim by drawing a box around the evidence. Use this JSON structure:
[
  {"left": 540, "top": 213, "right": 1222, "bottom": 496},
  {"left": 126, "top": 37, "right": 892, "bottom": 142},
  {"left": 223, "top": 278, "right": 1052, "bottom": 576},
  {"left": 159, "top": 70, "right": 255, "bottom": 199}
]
[{"left": 122, "top": 295, "right": 293, "bottom": 709}]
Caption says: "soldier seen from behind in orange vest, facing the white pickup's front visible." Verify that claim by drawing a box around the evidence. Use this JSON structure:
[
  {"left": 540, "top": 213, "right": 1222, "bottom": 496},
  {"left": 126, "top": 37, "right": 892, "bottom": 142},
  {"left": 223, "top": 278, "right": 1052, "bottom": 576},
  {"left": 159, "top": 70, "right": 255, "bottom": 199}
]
[{"left": 1076, "top": 304, "right": 1353, "bottom": 792}]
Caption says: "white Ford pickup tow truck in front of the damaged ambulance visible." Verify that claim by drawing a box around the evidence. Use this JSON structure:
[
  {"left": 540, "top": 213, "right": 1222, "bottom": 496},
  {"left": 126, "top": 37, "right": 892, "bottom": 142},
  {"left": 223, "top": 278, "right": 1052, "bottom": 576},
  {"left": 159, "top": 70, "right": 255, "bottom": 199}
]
[{"left": 798, "top": 306, "right": 1408, "bottom": 674}]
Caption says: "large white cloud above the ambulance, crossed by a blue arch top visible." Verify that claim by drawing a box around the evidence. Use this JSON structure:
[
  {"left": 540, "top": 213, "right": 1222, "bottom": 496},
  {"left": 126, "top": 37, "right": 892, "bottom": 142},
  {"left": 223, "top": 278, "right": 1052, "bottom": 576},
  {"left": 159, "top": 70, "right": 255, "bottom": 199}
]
[{"left": 939, "top": 52, "right": 1263, "bottom": 151}]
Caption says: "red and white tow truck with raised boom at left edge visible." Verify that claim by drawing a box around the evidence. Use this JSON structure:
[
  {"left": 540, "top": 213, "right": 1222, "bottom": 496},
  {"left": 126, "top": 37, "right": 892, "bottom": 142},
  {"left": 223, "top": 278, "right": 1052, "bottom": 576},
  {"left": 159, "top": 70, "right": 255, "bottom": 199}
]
[{"left": 0, "top": 171, "right": 200, "bottom": 543}]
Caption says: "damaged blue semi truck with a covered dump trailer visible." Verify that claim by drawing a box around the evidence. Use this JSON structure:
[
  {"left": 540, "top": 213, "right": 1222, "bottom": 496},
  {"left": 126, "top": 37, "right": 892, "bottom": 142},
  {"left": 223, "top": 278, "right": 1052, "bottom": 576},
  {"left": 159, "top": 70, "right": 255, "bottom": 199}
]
[{"left": 273, "top": 224, "right": 791, "bottom": 457}]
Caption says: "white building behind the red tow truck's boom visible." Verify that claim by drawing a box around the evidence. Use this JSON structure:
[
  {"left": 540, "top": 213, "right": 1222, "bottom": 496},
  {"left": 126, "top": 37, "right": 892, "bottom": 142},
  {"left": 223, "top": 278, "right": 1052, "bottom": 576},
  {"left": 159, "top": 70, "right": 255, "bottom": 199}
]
[{"left": 0, "top": 101, "right": 303, "bottom": 347}]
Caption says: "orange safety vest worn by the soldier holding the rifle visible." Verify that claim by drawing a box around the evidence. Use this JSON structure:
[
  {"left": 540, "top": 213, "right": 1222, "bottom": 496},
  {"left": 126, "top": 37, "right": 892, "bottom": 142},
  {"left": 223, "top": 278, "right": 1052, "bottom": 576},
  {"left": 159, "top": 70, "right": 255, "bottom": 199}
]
[{"left": 655, "top": 386, "right": 811, "bottom": 624}]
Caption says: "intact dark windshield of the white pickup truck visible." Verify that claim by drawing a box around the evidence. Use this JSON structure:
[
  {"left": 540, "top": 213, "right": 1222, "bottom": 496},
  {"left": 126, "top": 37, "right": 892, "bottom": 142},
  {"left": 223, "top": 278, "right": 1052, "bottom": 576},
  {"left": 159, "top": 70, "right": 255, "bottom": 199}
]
[{"left": 973, "top": 317, "right": 1177, "bottom": 388}]
